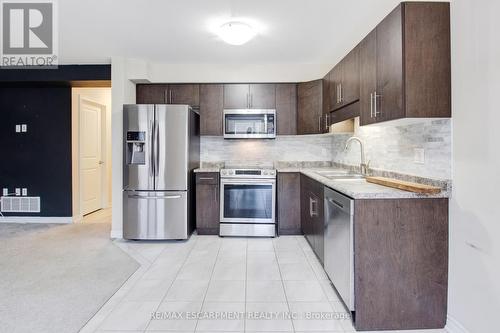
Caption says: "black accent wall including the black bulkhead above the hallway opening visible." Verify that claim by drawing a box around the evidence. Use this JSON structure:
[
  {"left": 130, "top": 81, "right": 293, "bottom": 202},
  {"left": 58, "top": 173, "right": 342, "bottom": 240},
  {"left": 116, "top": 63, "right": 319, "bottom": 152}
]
[{"left": 0, "top": 65, "right": 111, "bottom": 217}]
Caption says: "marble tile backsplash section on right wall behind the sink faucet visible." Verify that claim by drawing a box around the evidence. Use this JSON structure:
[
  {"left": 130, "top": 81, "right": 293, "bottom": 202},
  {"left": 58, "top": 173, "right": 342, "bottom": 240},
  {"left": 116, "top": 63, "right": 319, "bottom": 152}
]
[{"left": 332, "top": 119, "right": 452, "bottom": 179}]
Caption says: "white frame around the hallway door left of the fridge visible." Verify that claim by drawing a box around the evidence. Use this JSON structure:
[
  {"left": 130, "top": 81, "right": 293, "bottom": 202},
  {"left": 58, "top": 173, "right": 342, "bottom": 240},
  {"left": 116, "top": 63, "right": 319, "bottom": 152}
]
[{"left": 77, "top": 95, "right": 109, "bottom": 219}]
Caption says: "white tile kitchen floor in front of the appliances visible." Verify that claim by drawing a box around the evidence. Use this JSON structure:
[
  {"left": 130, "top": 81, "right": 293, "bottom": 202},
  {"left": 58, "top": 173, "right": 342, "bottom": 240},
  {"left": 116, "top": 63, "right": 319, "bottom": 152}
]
[{"left": 82, "top": 235, "right": 445, "bottom": 333}]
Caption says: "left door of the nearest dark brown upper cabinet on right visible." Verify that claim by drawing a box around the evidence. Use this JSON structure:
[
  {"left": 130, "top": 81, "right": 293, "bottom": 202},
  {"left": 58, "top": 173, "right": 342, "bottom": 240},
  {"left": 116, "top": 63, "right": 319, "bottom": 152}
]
[{"left": 359, "top": 30, "right": 377, "bottom": 125}]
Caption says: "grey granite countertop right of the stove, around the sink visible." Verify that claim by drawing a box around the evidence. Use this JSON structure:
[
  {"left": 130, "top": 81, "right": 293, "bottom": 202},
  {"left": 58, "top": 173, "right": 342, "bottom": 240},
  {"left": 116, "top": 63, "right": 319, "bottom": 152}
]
[{"left": 278, "top": 167, "right": 449, "bottom": 199}]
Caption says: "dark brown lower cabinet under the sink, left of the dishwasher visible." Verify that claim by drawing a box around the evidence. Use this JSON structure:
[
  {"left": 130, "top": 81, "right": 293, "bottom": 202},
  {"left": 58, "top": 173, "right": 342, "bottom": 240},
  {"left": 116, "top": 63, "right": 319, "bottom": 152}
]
[{"left": 300, "top": 175, "right": 325, "bottom": 263}]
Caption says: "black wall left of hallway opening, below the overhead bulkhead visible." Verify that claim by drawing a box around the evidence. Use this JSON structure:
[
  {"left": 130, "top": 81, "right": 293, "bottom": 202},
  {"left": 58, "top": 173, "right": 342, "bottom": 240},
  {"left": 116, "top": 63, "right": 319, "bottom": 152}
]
[{"left": 0, "top": 85, "right": 72, "bottom": 216}]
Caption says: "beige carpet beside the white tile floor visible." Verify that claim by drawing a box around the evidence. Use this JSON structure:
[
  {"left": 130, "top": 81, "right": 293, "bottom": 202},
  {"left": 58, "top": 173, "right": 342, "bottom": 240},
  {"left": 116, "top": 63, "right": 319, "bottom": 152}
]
[{"left": 0, "top": 221, "right": 139, "bottom": 332}]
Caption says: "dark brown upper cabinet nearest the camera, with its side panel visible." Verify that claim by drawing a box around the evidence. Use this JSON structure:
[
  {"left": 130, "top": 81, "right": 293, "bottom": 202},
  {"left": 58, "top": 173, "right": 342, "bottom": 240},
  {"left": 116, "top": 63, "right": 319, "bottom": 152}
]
[{"left": 359, "top": 2, "right": 451, "bottom": 125}]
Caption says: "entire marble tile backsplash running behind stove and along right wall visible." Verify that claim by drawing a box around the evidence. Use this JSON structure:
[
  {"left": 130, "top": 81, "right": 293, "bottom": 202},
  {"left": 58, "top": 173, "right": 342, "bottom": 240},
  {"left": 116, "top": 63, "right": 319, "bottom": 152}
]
[{"left": 201, "top": 119, "right": 452, "bottom": 180}]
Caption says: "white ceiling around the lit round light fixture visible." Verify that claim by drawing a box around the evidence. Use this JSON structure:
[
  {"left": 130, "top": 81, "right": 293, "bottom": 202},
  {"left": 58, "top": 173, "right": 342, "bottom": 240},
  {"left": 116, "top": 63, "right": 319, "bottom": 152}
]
[{"left": 58, "top": 0, "right": 412, "bottom": 65}]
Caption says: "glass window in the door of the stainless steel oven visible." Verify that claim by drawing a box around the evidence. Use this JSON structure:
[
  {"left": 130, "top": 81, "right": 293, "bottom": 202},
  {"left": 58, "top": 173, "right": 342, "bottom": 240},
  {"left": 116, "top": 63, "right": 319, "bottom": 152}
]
[{"left": 224, "top": 184, "right": 273, "bottom": 219}]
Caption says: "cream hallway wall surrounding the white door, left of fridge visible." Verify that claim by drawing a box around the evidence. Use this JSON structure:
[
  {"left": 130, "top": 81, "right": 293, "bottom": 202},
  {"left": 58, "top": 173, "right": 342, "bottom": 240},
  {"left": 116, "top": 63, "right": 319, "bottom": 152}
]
[{"left": 71, "top": 88, "right": 112, "bottom": 222}]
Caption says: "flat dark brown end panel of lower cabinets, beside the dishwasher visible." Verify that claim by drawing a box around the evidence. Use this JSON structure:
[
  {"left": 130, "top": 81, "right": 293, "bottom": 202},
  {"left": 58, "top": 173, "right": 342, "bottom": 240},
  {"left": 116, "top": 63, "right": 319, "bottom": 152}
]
[{"left": 354, "top": 199, "right": 448, "bottom": 330}]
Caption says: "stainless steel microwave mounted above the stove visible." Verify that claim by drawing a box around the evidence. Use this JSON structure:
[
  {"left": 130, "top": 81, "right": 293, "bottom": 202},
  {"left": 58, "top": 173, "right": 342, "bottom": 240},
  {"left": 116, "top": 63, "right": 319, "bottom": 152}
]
[{"left": 224, "top": 109, "right": 276, "bottom": 139}]
